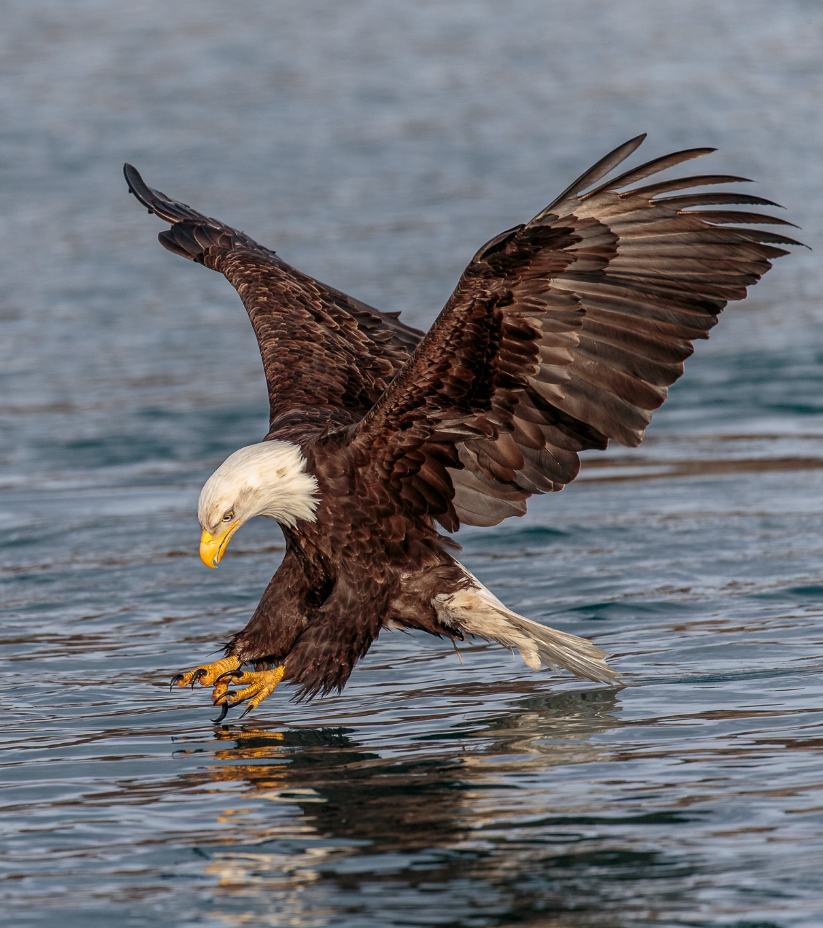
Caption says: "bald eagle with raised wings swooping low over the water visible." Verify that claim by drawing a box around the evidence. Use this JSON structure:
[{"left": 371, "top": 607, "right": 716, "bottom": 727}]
[{"left": 125, "top": 136, "right": 799, "bottom": 721}]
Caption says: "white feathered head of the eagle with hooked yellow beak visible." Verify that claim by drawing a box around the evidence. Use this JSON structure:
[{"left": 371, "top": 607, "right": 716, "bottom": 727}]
[{"left": 197, "top": 441, "right": 318, "bottom": 567}]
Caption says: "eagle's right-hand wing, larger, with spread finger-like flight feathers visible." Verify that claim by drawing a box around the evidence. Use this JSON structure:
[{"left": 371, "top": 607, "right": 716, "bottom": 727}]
[{"left": 351, "top": 136, "right": 799, "bottom": 530}]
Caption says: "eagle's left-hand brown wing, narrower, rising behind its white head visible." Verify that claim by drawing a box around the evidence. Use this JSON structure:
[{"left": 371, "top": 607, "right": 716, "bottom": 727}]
[{"left": 124, "top": 164, "right": 423, "bottom": 437}]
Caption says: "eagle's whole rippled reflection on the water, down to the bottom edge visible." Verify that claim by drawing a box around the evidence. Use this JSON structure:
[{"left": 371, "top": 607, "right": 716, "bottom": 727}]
[{"left": 190, "top": 689, "right": 631, "bottom": 925}]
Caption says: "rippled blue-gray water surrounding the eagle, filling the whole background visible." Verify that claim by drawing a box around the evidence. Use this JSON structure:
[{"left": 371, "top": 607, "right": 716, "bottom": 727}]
[{"left": 0, "top": 0, "right": 823, "bottom": 928}]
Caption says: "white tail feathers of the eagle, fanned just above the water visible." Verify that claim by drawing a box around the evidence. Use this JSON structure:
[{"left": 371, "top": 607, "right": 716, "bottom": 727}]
[{"left": 432, "top": 568, "right": 620, "bottom": 683}]
